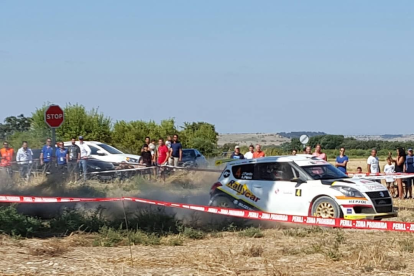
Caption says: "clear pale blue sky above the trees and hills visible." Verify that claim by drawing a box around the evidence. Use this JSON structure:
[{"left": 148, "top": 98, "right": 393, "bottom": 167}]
[{"left": 0, "top": 0, "right": 414, "bottom": 134}]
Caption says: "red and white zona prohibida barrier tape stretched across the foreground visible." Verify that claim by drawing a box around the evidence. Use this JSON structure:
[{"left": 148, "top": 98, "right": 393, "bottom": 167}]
[{"left": 0, "top": 195, "right": 414, "bottom": 232}]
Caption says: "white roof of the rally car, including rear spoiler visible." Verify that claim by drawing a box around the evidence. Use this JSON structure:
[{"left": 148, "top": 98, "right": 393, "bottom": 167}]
[{"left": 225, "top": 154, "right": 328, "bottom": 166}]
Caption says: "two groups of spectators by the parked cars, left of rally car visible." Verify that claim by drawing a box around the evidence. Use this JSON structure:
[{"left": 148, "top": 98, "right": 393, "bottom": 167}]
[{"left": 0, "top": 134, "right": 182, "bottom": 182}]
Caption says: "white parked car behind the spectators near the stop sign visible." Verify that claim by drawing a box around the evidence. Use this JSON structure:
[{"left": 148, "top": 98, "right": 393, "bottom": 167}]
[{"left": 64, "top": 141, "right": 140, "bottom": 163}]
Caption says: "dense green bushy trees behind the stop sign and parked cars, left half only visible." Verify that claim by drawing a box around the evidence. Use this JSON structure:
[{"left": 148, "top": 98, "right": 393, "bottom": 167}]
[{"left": 0, "top": 104, "right": 218, "bottom": 156}]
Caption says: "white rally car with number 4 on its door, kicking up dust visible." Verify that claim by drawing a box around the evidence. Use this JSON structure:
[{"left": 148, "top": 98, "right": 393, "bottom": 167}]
[{"left": 209, "top": 155, "right": 397, "bottom": 220}]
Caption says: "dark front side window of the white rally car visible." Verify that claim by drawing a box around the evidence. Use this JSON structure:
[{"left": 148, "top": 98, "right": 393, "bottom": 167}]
[{"left": 256, "top": 162, "right": 295, "bottom": 181}]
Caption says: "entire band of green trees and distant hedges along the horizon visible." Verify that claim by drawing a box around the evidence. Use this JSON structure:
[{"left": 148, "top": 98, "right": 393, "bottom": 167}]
[{"left": 0, "top": 104, "right": 414, "bottom": 157}]
